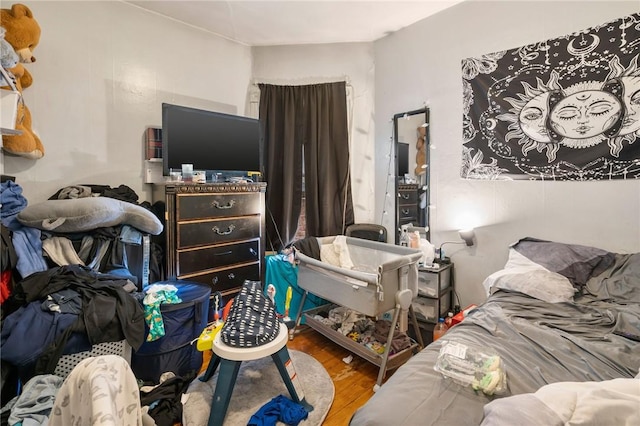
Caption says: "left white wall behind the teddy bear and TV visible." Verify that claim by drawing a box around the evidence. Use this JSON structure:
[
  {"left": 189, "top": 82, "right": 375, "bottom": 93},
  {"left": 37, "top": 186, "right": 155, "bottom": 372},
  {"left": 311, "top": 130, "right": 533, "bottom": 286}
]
[{"left": 3, "top": 1, "right": 251, "bottom": 203}]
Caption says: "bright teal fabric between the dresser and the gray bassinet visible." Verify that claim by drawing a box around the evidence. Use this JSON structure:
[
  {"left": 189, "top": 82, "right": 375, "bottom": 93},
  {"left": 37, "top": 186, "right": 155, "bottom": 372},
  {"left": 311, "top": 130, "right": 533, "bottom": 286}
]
[{"left": 264, "top": 254, "right": 329, "bottom": 324}]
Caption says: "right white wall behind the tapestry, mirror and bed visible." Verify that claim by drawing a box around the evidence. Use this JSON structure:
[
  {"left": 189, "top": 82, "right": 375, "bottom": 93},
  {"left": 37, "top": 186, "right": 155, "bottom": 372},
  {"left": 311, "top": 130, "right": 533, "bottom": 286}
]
[{"left": 375, "top": 1, "right": 640, "bottom": 306}]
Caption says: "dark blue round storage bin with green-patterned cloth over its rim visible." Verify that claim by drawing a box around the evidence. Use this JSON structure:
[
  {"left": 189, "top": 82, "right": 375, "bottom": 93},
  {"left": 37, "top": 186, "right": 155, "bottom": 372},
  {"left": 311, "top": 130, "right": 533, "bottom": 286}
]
[{"left": 131, "top": 280, "right": 211, "bottom": 383}]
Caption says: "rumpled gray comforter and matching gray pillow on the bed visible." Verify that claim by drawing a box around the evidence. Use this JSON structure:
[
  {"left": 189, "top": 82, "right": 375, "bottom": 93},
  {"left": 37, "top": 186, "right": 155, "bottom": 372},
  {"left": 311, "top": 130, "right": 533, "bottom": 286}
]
[{"left": 351, "top": 239, "right": 640, "bottom": 426}]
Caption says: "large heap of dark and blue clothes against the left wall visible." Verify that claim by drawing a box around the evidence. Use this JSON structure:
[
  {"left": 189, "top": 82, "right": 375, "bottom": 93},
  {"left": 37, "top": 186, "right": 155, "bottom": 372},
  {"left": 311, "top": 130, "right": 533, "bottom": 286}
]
[{"left": 0, "top": 180, "right": 168, "bottom": 419}]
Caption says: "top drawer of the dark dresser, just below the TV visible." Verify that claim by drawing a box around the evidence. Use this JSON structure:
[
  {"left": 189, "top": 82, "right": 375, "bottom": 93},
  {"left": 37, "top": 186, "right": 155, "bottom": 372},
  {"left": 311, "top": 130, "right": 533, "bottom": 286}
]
[{"left": 176, "top": 192, "right": 262, "bottom": 221}]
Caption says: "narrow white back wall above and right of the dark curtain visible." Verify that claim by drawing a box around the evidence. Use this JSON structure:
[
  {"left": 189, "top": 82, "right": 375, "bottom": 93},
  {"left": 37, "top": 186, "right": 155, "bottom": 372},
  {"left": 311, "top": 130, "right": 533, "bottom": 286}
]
[{"left": 253, "top": 43, "right": 381, "bottom": 223}]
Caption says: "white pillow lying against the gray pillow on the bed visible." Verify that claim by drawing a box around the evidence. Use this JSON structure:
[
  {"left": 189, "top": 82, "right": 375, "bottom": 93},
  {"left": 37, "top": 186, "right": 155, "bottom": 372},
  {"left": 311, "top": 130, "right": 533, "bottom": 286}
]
[{"left": 482, "top": 266, "right": 575, "bottom": 303}]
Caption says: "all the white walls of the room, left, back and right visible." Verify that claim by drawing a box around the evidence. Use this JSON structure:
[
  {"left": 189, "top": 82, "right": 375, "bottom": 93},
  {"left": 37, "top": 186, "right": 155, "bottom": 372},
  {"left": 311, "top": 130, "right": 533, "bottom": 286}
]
[{"left": 6, "top": 1, "right": 640, "bottom": 305}]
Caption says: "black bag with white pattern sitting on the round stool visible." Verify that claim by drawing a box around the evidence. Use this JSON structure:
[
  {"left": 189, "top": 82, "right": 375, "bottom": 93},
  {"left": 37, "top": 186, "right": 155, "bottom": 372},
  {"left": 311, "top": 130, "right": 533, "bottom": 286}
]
[{"left": 220, "top": 280, "right": 280, "bottom": 348}]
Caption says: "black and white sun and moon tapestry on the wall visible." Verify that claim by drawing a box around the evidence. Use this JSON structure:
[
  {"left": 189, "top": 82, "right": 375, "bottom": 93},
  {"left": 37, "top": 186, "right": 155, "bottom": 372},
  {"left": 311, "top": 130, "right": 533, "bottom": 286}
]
[{"left": 461, "top": 13, "right": 640, "bottom": 181}]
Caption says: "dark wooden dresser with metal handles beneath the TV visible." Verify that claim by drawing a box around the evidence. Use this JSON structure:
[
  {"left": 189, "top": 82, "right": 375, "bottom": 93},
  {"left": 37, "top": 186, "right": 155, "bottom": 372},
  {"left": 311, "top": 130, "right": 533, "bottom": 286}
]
[{"left": 153, "top": 183, "right": 267, "bottom": 295}]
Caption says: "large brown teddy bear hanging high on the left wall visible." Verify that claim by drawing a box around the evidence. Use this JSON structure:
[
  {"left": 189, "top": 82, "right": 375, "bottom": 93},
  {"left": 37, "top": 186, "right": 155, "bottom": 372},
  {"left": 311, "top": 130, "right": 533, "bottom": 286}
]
[{"left": 0, "top": 4, "right": 44, "bottom": 159}]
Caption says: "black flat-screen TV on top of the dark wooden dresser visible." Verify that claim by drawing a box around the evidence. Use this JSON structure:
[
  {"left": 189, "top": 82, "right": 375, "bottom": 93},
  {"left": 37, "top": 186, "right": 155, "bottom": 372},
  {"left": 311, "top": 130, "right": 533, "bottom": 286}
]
[{"left": 162, "top": 103, "right": 262, "bottom": 176}]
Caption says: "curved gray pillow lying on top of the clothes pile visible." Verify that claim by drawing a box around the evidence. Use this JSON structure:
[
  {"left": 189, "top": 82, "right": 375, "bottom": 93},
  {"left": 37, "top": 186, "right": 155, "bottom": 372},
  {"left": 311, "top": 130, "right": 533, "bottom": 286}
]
[{"left": 17, "top": 197, "right": 162, "bottom": 235}]
